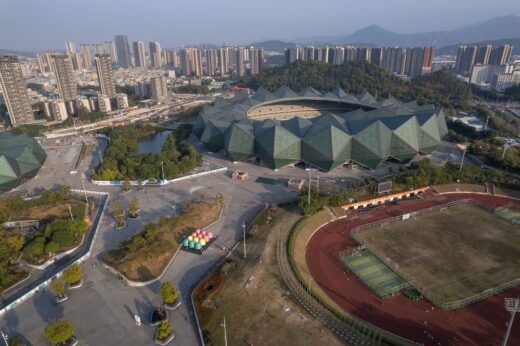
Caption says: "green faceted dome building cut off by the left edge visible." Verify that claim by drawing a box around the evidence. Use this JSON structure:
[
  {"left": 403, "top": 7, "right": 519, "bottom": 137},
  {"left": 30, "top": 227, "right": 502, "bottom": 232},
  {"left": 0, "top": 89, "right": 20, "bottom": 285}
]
[{"left": 0, "top": 132, "right": 47, "bottom": 190}]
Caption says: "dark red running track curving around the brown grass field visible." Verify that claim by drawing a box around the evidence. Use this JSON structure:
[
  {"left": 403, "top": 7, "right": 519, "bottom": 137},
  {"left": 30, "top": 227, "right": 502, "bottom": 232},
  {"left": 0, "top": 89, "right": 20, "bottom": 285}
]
[{"left": 305, "top": 193, "right": 520, "bottom": 345}]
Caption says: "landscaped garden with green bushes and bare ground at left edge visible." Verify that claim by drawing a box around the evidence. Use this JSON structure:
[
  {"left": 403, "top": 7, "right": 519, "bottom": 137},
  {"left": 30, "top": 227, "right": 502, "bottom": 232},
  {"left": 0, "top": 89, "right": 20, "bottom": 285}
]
[{"left": 0, "top": 187, "right": 93, "bottom": 292}]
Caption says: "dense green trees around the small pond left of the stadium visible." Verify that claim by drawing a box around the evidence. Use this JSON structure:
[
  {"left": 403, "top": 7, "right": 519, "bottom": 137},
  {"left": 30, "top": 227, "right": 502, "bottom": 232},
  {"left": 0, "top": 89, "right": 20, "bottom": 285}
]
[{"left": 92, "top": 124, "right": 202, "bottom": 180}]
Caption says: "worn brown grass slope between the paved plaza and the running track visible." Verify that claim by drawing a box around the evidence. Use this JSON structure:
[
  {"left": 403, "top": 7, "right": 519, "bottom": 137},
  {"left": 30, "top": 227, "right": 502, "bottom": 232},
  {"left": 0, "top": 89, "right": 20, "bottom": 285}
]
[{"left": 194, "top": 206, "right": 341, "bottom": 345}]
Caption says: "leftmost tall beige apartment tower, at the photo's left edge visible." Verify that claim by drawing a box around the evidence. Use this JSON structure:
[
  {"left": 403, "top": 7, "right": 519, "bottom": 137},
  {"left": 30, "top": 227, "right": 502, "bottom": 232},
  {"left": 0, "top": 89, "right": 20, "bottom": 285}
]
[{"left": 0, "top": 55, "right": 34, "bottom": 127}]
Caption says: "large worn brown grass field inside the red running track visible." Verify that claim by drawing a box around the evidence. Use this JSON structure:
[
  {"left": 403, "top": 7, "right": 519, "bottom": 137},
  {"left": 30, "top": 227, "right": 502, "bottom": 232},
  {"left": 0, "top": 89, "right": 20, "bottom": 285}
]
[{"left": 355, "top": 204, "right": 520, "bottom": 305}]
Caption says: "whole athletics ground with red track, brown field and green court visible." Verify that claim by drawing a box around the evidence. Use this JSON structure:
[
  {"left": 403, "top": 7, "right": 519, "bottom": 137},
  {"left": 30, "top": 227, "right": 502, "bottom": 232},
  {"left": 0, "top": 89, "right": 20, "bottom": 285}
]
[{"left": 302, "top": 191, "right": 520, "bottom": 345}]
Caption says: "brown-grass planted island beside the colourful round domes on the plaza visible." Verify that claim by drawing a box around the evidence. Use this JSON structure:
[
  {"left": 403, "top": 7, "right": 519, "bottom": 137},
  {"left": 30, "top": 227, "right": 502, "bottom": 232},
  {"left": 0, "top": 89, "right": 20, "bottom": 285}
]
[{"left": 103, "top": 197, "right": 223, "bottom": 281}]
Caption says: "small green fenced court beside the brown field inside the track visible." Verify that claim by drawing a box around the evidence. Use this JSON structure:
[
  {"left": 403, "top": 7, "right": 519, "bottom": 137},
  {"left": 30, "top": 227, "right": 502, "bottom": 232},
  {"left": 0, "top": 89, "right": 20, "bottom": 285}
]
[{"left": 340, "top": 250, "right": 404, "bottom": 297}]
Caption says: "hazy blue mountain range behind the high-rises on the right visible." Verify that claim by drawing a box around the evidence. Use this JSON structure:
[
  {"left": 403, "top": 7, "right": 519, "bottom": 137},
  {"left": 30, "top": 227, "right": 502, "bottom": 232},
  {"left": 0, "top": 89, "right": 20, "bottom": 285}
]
[{"left": 294, "top": 15, "right": 520, "bottom": 47}]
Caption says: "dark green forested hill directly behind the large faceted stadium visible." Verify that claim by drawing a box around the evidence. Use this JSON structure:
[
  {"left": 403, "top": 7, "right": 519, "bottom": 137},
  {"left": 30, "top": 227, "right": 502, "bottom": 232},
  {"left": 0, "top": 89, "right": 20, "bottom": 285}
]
[{"left": 240, "top": 61, "right": 472, "bottom": 111}]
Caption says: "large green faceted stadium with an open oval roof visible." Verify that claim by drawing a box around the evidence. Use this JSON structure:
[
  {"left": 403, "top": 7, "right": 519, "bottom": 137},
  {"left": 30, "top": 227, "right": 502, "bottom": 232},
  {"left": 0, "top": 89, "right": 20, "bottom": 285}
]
[{"left": 193, "top": 87, "right": 448, "bottom": 171}]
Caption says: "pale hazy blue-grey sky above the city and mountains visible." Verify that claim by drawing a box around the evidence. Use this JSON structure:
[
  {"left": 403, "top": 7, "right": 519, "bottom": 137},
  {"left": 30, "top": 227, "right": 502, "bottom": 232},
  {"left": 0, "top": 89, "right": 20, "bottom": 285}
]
[{"left": 0, "top": 0, "right": 520, "bottom": 51}]
